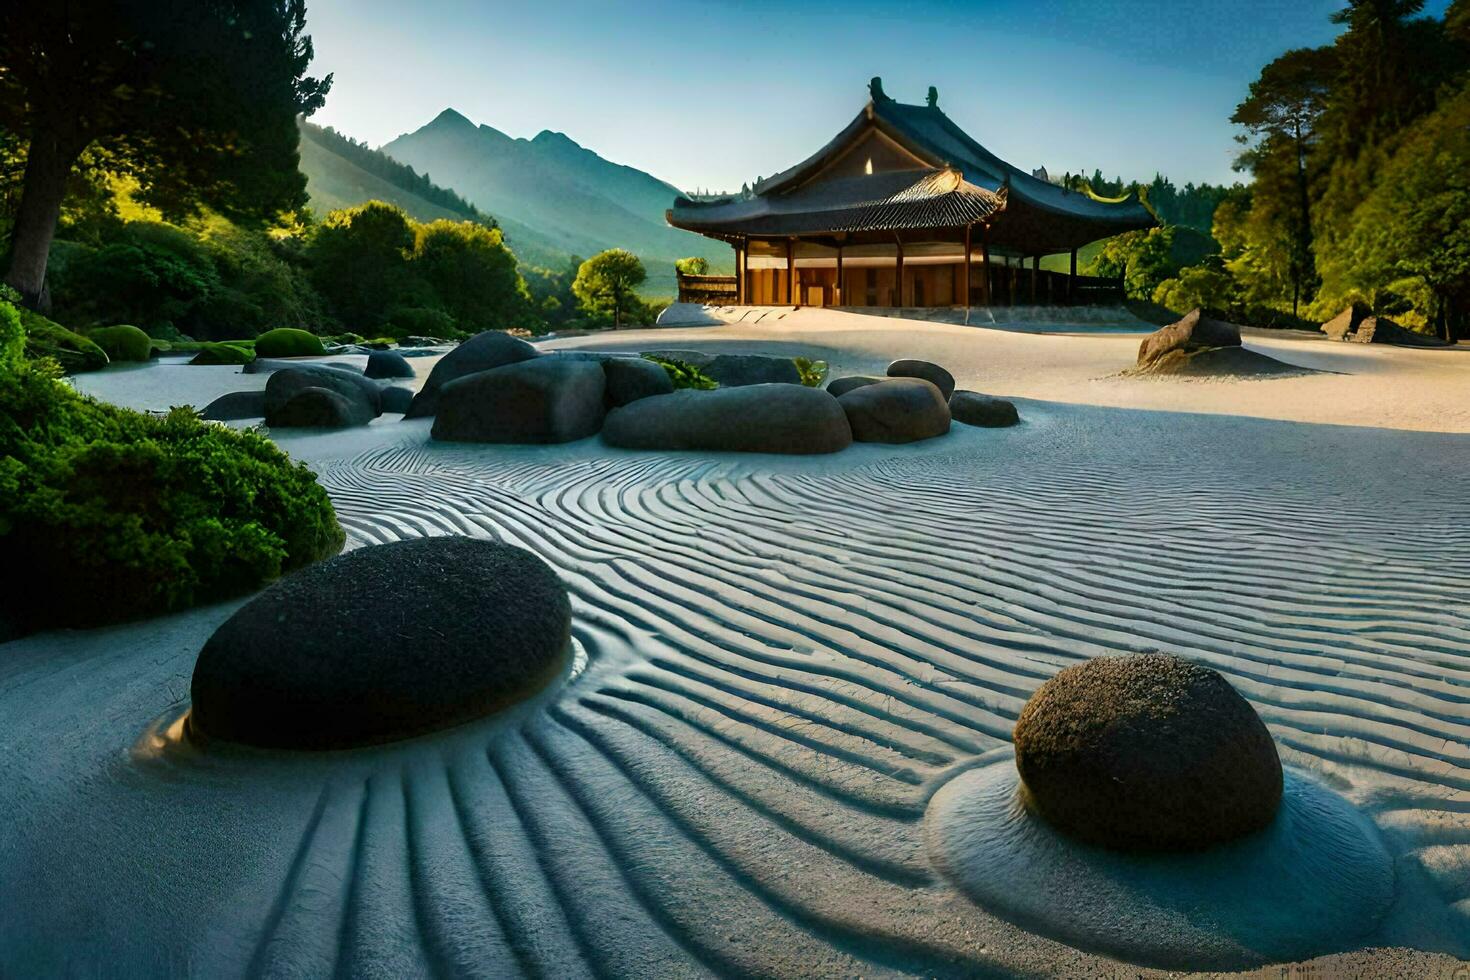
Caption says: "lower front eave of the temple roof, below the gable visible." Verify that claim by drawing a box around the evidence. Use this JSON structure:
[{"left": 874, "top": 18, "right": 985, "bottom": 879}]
[{"left": 669, "top": 169, "right": 1004, "bottom": 235}]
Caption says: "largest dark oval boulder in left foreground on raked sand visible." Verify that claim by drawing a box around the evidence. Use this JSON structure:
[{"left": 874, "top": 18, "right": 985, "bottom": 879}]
[{"left": 188, "top": 538, "right": 572, "bottom": 749}]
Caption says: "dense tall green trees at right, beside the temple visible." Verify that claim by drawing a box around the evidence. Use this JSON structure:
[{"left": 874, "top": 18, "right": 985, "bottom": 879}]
[{"left": 1061, "top": 0, "right": 1470, "bottom": 338}]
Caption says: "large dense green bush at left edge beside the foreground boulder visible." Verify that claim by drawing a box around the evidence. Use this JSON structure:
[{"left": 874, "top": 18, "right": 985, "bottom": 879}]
[{"left": 0, "top": 348, "right": 344, "bottom": 629}]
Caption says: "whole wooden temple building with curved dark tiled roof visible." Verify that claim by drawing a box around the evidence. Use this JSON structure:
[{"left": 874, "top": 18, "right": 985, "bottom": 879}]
[{"left": 667, "top": 78, "right": 1158, "bottom": 307}]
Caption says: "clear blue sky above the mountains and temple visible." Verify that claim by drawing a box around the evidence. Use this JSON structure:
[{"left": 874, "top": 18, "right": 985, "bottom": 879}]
[{"left": 309, "top": 0, "right": 1448, "bottom": 190}]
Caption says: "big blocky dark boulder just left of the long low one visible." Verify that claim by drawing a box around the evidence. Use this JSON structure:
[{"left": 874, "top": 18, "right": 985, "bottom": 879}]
[{"left": 429, "top": 357, "right": 606, "bottom": 442}]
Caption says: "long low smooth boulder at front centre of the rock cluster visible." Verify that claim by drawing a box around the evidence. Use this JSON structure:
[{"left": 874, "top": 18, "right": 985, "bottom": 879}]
[{"left": 603, "top": 383, "right": 853, "bottom": 454}]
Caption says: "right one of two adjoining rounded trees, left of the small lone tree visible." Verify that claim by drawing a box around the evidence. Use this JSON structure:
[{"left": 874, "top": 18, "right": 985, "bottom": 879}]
[{"left": 412, "top": 220, "right": 531, "bottom": 332}]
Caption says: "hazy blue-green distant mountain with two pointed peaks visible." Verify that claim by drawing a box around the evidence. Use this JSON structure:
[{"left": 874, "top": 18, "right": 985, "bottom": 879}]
[{"left": 382, "top": 109, "right": 732, "bottom": 291}]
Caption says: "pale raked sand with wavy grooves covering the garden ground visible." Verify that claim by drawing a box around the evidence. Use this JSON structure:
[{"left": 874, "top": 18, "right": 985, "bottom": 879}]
[{"left": 0, "top": 318, "right": 1470, "bottom": 977}]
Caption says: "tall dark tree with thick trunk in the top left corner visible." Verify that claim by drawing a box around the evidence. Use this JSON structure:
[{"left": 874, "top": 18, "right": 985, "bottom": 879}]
[{"left": 0, "top": 0, "right": 331, "bottom": 306}]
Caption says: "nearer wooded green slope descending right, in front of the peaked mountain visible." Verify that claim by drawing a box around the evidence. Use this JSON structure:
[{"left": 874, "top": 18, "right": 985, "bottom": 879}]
[{"left": 301, "top": 123, "right": 570, "bottom": 276}]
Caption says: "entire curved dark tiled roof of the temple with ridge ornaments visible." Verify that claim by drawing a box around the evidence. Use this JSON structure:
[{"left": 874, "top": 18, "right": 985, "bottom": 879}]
[{"left": 667, "top": 78, "right": 1158, "bottom": 256}]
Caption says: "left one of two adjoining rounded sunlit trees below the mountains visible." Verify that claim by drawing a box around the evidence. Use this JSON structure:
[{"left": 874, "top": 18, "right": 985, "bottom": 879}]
[{"left": 307, "top": 201, "right": 434, "bottom": 331}]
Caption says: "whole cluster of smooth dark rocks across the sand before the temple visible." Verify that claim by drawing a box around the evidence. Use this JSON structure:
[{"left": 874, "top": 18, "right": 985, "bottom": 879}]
[{"left": 195, "top": 331, "right": 1020, "bottom": 454}]
